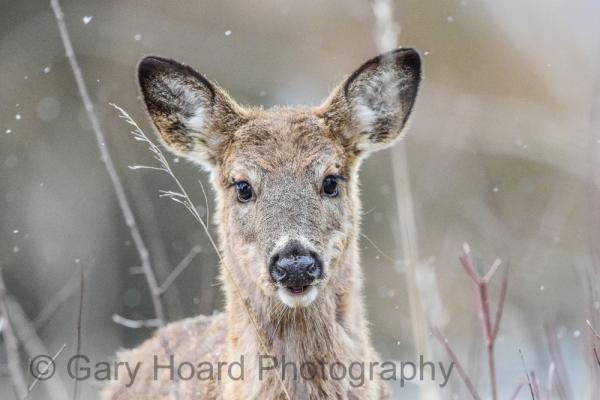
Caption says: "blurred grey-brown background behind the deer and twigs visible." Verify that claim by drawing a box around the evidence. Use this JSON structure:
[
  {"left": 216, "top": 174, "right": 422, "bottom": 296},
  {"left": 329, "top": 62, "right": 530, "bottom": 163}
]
[{"left": 0, "top": 0, "right": 600, "bottom": 399}]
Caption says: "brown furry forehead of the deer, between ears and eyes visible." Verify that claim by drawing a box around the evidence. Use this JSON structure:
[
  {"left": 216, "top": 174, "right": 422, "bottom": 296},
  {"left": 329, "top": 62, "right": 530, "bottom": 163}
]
[{"left": 221, "top": 108, "right": 352, "bottom": 181}]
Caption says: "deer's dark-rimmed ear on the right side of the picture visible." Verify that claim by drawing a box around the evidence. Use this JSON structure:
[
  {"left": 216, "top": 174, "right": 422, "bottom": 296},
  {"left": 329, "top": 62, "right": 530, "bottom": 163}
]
[{"left": 317, "top": 49, "right": 421, "bottom": 155}]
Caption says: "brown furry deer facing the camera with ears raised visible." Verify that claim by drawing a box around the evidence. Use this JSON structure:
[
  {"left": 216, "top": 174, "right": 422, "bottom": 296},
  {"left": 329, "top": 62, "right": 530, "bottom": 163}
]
[{"left": 102, "top": 48, "right": 421, "bottom": 400}]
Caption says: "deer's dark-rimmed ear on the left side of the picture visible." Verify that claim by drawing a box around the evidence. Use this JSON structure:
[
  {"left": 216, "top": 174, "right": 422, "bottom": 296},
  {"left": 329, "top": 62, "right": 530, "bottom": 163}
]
[{"left": 138, "top": 56, "right": 246, "bottom": 167}]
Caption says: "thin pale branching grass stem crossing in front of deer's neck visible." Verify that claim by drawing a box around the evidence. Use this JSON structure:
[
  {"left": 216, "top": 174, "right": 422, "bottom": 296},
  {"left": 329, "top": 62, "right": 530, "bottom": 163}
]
[{"left": 110, "top": 103, "right": 291, "bottom": 400}]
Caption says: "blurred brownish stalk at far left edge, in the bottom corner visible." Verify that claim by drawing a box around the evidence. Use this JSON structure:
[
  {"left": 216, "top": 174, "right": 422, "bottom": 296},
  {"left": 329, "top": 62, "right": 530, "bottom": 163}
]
[{"left": 0, "top": 267, "right": 27, "bottom": 399}]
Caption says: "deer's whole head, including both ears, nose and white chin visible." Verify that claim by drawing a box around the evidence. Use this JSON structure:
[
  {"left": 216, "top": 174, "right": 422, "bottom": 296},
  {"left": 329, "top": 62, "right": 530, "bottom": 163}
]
[{"left": 139, "top": 50, "right": 420, "bottom": 307}]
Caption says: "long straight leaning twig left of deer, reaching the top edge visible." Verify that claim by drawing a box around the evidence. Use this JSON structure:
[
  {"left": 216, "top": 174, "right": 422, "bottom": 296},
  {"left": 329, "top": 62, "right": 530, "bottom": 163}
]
[{"left": 50, "top": 0, "right": 165, "bottom": 325}]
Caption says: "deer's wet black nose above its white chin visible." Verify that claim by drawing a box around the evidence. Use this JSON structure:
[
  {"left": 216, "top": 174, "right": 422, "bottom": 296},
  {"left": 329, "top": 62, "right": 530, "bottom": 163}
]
[{"left": 269, "top": 242, "right": 323, "bottom": 290}]
